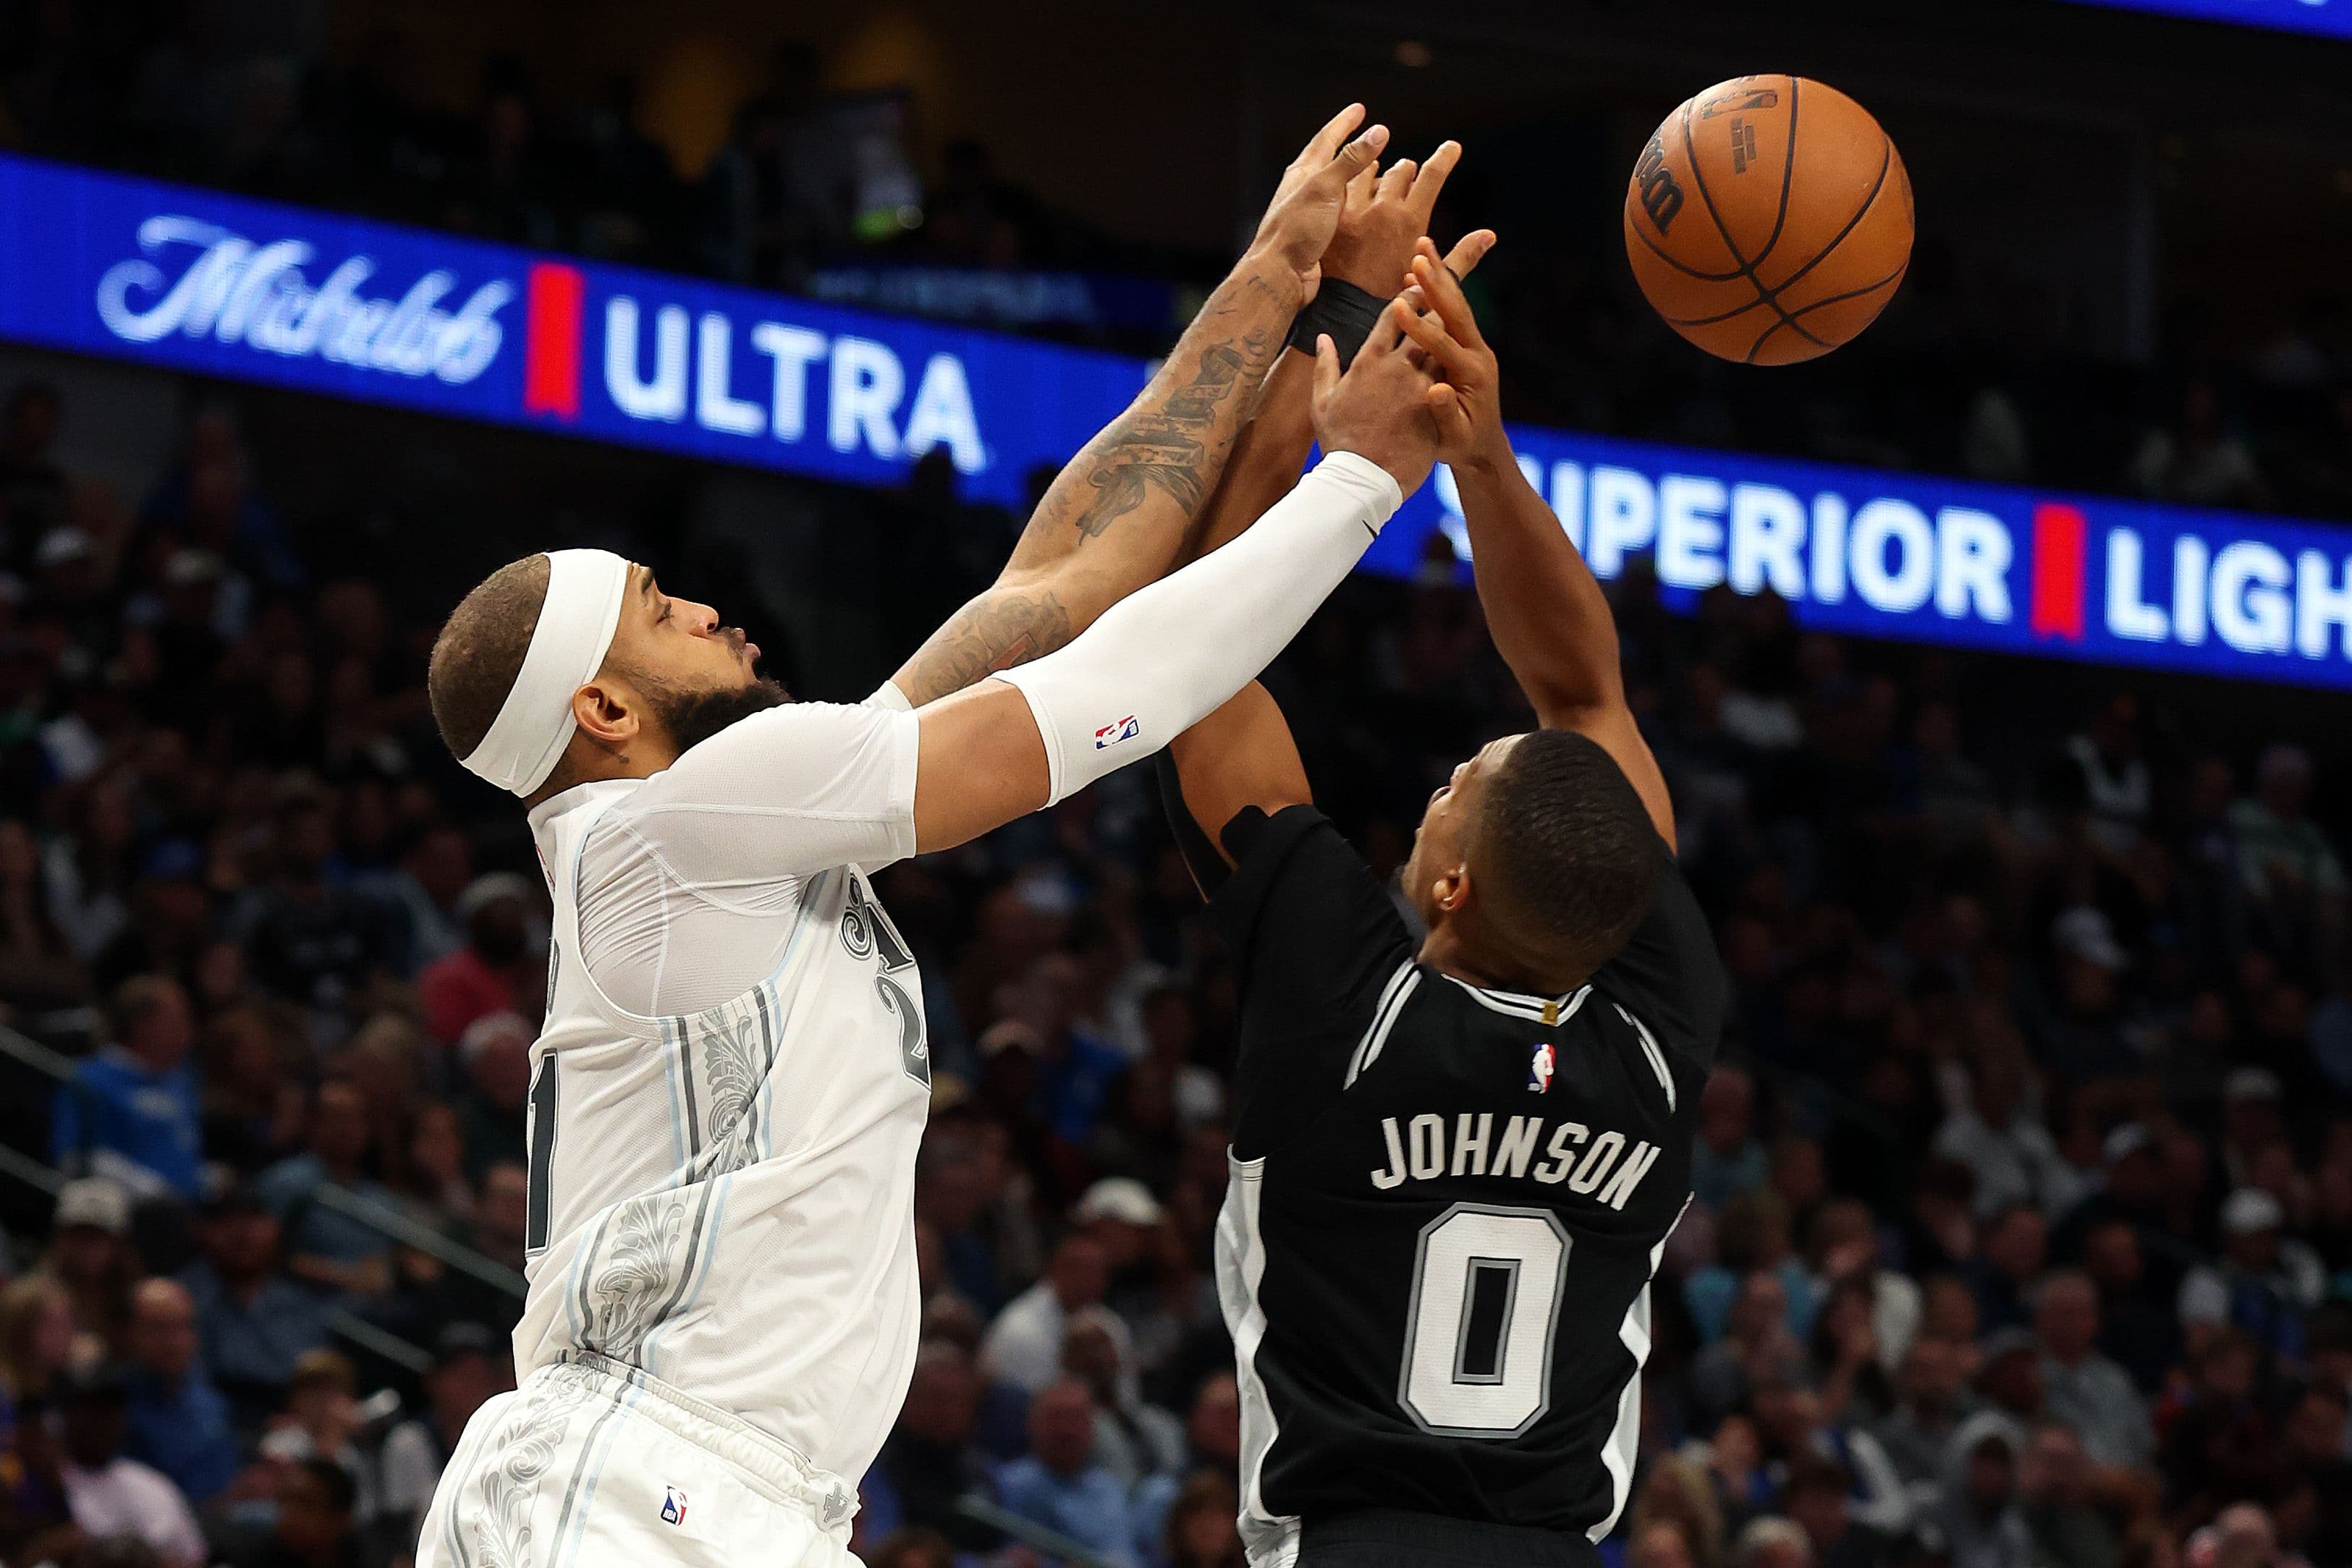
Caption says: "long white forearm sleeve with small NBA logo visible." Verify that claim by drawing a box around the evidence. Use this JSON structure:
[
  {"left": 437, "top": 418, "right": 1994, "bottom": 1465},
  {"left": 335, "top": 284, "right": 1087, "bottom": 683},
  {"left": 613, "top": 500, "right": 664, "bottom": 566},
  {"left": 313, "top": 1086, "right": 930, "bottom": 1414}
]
[{"left": 995, "top": 452, "right": 1404, "bottom": 804}]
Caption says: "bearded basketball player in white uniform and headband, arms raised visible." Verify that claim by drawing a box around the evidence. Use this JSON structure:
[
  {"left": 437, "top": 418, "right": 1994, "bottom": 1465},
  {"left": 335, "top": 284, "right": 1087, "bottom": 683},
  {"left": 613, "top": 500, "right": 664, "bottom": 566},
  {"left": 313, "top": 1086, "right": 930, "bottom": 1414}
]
[{"left": 416, "top": 108, "right": 1484, "bottom": 1568}]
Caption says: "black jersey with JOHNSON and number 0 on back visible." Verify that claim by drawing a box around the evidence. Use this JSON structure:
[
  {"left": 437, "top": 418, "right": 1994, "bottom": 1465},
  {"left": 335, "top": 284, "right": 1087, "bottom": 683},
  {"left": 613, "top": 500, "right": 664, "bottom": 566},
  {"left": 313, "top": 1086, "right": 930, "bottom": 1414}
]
[{"left": 1172, "top": 797, "right": 1727, "bottom": 1564}]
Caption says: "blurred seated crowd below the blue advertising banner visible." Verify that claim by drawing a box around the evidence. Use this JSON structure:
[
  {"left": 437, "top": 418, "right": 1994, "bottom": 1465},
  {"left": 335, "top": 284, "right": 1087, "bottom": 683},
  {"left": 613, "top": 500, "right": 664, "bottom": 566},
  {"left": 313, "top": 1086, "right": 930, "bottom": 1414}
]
[{"left": 0, "top": 350, "right": 2352, "bottom": 1568}]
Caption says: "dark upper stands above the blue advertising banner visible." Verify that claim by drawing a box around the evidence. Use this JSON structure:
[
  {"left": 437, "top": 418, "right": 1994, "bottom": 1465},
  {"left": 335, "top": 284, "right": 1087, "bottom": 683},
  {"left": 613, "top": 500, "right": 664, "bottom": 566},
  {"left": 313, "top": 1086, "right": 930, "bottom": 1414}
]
[{"left": 14, "top": 0, "right": 2352, "bottom": 517}]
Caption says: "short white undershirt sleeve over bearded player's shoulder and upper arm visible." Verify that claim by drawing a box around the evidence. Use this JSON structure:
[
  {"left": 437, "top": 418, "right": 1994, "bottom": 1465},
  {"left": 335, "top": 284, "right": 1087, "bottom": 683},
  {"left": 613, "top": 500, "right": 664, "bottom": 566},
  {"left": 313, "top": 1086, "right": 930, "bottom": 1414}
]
[{"left": 591, "top": 703, "right": 922, "bottom": 894}]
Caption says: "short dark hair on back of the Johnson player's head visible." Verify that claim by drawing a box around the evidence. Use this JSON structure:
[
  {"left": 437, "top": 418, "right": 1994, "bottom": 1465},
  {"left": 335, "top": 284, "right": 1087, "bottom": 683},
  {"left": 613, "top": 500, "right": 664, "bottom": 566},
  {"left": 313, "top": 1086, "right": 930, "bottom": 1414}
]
[{"left": 1470, "top": 729, "right": 1665, "bottom": 973}]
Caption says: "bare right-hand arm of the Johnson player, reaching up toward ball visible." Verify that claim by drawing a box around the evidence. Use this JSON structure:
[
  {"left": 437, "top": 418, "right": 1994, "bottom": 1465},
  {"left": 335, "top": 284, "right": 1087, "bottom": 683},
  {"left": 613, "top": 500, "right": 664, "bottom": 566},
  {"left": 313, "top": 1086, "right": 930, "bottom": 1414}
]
[{"left": 1402, "top": 242, "right": 1675, "bottom": 847}]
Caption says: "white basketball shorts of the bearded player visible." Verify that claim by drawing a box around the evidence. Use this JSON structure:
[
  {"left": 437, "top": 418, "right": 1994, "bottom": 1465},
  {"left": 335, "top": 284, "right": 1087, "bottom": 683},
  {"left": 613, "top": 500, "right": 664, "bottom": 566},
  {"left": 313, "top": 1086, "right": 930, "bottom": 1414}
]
[{"left": 416, "top": 1354, "right": 858, "bottom": 1568}]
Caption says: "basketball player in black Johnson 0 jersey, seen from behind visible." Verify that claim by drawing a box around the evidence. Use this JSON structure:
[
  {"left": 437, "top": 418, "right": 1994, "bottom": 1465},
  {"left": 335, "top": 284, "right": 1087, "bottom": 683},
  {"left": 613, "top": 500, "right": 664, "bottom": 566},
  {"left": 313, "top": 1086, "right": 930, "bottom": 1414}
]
[{"left": 1162, "top": 240, "right": 1727, "bottom": 1568}]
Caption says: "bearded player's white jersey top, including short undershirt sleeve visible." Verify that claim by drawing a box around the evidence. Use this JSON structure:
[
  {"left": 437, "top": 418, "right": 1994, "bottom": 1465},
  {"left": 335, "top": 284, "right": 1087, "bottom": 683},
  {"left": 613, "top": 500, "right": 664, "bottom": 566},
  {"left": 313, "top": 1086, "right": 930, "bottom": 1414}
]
[{"left": 515, "top": 703, "right": 931, "bottom": 1476}]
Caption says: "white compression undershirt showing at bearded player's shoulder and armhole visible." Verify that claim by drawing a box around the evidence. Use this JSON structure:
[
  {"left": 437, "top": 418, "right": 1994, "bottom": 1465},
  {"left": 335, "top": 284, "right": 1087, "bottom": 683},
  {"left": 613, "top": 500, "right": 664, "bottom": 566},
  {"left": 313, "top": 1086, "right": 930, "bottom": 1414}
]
[{"left": 579, "top": 687, "right": 920, "bottom": 1018}]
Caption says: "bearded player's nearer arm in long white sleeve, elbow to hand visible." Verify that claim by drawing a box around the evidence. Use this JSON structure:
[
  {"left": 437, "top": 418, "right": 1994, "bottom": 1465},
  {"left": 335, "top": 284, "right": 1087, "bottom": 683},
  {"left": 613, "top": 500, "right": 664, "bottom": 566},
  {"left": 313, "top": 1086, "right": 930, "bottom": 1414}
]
[{"left": 915, "top": 303, "right": 1435, "bottom": 849}]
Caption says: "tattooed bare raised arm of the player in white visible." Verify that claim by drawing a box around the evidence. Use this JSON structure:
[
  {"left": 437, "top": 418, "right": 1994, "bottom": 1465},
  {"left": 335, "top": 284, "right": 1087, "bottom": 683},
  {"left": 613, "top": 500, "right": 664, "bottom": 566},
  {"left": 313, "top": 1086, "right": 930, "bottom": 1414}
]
[{"left": 892, "top": 103, "right": 1388, "bottom": 708}]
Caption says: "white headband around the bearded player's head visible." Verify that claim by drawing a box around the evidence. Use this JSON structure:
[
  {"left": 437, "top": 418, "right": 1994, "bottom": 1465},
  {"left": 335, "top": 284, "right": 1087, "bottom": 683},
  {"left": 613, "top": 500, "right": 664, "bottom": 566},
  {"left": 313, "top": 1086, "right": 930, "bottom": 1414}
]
[{"left": 466, "top": 550, "right": 628, "bottom": 800}]
